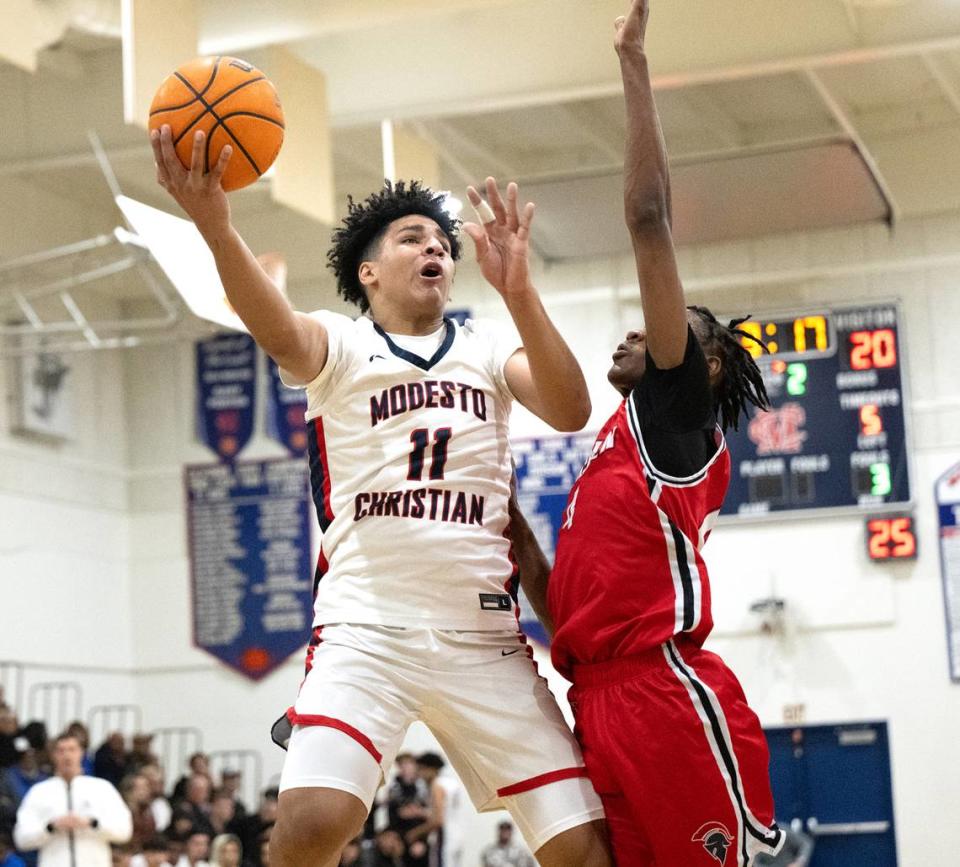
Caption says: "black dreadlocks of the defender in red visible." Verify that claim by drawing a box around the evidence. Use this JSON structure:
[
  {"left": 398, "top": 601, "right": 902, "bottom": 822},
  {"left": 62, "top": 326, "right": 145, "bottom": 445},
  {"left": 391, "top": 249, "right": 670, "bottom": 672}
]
[{"left": 688, "top": 306, "right": 770, "bottom": 430}]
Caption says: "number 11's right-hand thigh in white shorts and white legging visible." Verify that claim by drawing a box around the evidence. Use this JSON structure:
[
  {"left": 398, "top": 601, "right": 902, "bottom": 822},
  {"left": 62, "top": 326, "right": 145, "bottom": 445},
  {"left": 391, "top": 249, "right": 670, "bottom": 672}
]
[{"left": 423, "top": 633, "right": 603, "bottom": 851}]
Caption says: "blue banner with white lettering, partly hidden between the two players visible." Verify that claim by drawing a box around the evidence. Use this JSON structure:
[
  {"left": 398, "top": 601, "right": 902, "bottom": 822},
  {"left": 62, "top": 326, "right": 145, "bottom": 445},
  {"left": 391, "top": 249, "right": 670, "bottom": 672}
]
[{"left": 511, "top": 434, "right": 596, "bottom": 644}]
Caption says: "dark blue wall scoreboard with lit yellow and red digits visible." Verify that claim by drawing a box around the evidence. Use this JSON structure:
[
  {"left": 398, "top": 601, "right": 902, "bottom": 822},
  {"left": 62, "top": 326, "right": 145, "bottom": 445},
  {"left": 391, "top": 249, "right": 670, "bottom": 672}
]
[{"left": 721, "top": 304, "right": 910, "bottom": 517}]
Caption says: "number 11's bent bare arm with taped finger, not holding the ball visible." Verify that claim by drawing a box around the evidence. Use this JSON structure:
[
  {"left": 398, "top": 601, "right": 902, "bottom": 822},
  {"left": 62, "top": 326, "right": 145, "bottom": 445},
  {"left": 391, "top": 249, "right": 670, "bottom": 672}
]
[{"left": 463, "top": 178, "right": 590, "bottom": 431}]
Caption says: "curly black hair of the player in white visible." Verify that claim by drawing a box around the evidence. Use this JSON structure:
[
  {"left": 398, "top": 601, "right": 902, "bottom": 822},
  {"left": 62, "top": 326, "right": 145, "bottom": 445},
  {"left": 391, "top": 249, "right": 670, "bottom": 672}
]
[{"left": 327, "top": 181, "right": 462, "bottom": 313}]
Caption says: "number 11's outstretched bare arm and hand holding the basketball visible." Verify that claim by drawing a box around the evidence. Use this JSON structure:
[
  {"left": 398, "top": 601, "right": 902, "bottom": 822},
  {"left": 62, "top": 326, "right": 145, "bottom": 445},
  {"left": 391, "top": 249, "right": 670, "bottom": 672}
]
[{"left": 150, "top": 125, "right": 327, "bottom": 382}]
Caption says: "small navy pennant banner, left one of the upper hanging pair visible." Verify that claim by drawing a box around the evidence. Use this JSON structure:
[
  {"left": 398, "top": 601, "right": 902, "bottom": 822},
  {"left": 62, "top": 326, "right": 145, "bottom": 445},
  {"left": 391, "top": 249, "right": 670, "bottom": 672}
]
[{"left": 196, "top": 333, "right": 257, "bottom": 461}]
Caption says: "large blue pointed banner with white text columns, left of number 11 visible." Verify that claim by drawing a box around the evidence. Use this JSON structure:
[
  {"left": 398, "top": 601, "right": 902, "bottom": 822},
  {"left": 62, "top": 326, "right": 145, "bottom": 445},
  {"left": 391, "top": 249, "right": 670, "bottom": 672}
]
[{"left": 185, "top": 458, "right": 313, "bottom": 680}]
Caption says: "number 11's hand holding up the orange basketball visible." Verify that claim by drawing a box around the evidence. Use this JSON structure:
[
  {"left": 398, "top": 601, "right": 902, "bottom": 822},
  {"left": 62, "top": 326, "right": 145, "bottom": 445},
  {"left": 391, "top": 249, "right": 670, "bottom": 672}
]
[{"left": 150, "top": 124, "right": 233, "bottom": 238}]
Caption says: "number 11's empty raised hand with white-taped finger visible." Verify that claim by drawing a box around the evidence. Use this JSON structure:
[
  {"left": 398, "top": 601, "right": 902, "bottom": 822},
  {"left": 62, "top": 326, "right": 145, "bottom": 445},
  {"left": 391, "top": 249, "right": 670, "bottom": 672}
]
[{"left": 463, "top": 178, "right": 534, "bottom": 299}]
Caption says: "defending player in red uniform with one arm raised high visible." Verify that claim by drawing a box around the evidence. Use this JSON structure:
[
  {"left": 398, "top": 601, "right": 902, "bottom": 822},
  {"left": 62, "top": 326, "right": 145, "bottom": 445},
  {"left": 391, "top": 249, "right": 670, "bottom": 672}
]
[{"left": 514, "top": 0, "right": 783, "bottom": 867}]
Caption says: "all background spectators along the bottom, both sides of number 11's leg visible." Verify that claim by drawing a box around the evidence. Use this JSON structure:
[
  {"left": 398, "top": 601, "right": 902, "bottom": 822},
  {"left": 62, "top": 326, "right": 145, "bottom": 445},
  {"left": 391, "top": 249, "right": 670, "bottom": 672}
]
[{"left": 0, "top": 695, "right": 534, "bottom": 867}]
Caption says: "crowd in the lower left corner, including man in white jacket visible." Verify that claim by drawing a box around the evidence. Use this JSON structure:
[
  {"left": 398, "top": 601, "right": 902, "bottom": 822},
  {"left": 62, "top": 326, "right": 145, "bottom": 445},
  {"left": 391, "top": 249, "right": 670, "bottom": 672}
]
[{"left": 0, "top": 697, "right": 278, "bottom": 867}]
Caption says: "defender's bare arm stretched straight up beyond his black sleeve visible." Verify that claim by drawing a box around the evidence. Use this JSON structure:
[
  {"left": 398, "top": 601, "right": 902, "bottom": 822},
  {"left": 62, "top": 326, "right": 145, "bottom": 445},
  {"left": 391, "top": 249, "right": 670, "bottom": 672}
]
[{"left": 615, "top": 0, "right": 687, "bottom": 369}]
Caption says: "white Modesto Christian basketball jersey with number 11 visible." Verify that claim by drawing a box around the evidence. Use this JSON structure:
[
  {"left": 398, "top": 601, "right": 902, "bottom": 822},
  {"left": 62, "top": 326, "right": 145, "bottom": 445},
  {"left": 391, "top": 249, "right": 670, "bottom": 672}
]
[{"left": 286, "top": 311, "right": 519, "bottom": 630}]
